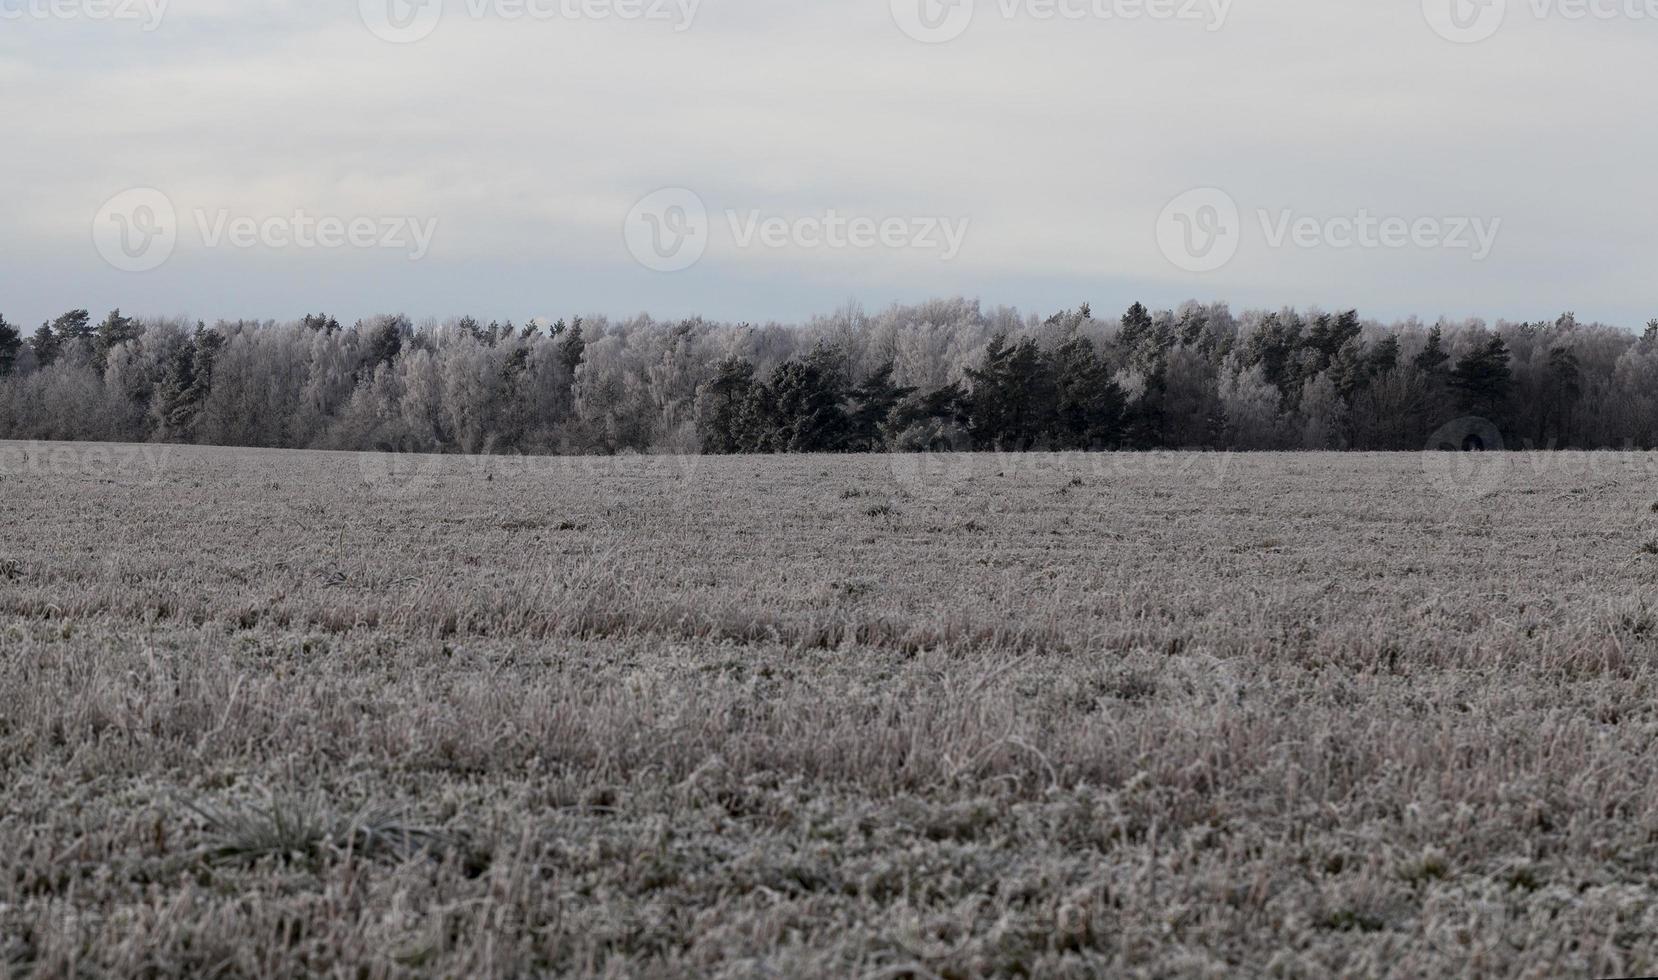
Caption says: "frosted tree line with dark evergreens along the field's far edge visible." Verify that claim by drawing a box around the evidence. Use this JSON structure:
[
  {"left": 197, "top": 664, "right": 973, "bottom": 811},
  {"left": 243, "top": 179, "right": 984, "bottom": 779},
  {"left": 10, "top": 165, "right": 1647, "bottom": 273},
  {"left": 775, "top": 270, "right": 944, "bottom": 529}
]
[{"left": 0, "top": 298, "right": 1658, "bottom": 453}]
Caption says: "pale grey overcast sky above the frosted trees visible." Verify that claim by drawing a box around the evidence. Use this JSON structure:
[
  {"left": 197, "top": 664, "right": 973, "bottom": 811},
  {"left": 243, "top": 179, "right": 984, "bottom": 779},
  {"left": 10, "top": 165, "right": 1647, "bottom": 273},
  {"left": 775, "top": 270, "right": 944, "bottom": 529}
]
[{"left": 0, "top": 0, "right": 1658, "bottom": 328}]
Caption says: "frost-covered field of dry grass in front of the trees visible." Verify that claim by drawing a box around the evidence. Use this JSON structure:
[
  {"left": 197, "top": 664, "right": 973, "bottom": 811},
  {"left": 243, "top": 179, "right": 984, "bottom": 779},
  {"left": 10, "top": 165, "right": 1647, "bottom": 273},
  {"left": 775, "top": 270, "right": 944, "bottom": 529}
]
[{"left": 0, "top": 444, "right": 1658, "bottom": 977}]
